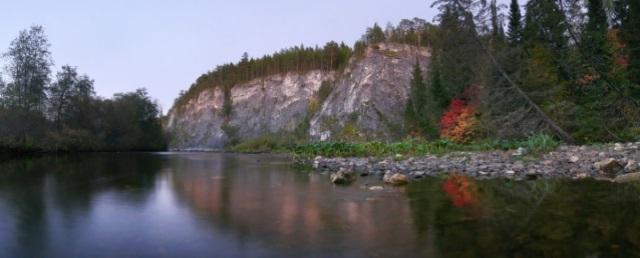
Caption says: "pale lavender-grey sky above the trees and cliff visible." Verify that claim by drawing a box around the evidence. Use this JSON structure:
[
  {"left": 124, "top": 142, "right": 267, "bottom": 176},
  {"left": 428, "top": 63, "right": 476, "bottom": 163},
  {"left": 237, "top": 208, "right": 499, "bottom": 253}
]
[{"left": 0, "top": 0, "right": 478, "bottom": 112}]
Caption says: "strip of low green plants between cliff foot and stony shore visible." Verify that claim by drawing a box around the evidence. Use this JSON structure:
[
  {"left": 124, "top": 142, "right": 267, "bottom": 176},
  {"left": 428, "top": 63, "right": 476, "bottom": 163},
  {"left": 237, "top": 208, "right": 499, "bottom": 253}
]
[{"left": 231, "top": 135, "right": 560, "bottom": 157}]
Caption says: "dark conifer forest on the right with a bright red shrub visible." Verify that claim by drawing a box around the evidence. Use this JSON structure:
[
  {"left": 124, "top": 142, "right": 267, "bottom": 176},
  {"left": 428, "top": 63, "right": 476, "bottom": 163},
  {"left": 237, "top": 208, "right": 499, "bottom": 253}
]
[{"left": 408, "top": 0, "right": 640, "bottom": 142}]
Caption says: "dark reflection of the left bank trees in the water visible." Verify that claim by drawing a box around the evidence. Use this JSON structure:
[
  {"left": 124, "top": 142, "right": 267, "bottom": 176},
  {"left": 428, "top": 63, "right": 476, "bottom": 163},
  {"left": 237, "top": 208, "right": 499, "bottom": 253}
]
[{"left": 0, "top": 154, "right": 163, "bottom": 257}]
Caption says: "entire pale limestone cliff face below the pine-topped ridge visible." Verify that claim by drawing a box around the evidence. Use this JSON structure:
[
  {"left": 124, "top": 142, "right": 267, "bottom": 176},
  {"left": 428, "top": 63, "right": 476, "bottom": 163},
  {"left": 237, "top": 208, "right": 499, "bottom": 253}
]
[{"left": 166, "top": 44, "right": 430, "bottom": 150}]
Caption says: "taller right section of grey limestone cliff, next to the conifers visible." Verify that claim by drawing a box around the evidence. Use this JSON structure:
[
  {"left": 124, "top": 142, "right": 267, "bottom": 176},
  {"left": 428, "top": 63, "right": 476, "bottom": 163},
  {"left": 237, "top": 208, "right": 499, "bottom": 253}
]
[{"left": 310, "top": 44, "right": 431, "bottom": 141}]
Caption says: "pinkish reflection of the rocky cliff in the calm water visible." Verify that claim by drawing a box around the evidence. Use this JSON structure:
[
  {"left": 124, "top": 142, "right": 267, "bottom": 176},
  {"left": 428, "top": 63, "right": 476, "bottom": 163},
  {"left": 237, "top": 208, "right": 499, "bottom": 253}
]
[{"left": 172, "top": 156, "right": 425, "bottom": 257}]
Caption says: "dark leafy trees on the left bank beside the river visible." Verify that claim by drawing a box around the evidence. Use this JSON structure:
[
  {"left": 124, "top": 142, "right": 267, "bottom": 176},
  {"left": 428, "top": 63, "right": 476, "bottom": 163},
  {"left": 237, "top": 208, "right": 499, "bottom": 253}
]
[{"left": 0, "top": 26, "right": 166, "bottom": 152}]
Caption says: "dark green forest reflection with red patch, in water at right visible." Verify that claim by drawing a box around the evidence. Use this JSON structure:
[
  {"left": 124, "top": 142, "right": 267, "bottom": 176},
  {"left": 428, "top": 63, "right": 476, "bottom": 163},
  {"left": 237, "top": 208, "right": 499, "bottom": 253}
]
[{"left": 407, "top": 175, "right": 640, "bottom": 257}]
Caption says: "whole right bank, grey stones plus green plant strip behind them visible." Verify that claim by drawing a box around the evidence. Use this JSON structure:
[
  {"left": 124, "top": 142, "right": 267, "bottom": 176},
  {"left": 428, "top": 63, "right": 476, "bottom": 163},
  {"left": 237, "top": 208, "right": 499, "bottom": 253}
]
[{"left": 224, "top": 134, "right": 640, "bottom": 185}]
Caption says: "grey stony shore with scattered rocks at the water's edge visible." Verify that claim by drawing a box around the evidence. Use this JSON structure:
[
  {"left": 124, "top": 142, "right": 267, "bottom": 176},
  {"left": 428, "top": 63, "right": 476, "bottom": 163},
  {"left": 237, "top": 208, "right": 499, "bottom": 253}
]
[{"left": 308, "top": 142, "right": 640, "bottom": 185}]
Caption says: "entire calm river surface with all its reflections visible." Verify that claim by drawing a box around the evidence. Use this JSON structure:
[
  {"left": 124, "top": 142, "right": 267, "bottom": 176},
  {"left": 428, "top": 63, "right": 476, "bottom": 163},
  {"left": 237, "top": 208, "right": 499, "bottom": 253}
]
[{"left": 0, "top": 153, "right": 640, "bottom": 257}]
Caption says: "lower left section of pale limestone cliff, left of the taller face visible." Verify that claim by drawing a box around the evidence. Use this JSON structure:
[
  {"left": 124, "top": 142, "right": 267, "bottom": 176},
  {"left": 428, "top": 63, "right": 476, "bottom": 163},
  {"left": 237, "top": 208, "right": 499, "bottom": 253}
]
[{"left": 166, "top": 71, "right": 333, "bottom": 150}]
